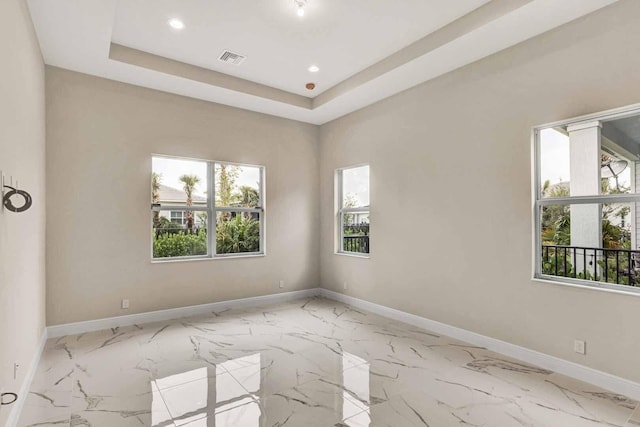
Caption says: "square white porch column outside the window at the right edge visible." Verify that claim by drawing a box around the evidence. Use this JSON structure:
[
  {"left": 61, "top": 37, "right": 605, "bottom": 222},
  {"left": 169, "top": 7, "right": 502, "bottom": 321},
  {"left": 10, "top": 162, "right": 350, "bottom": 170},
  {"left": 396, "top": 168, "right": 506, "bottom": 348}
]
[{"left": 567, "top": 121, "right": 602, "bottom": 280}]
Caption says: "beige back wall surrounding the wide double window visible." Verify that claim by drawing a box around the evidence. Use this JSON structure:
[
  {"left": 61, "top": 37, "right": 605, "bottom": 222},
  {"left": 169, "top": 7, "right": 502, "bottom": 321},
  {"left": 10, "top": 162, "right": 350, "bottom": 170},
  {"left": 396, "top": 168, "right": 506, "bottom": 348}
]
[{"left": 46, "top": 67, "right": 319, "bottom": 325}]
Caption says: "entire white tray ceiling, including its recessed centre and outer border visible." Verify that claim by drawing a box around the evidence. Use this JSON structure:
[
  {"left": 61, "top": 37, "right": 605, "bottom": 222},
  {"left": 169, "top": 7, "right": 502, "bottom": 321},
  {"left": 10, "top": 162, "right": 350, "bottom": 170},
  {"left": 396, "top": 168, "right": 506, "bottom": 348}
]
[{"left": 28, "top": 0, "right": 617, "bottom": 124}]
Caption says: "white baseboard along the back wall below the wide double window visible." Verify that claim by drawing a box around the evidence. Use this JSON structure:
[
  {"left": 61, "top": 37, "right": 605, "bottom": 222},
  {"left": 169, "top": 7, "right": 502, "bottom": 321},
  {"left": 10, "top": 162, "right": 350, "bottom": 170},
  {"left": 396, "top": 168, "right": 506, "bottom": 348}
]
[{"left": 47, "top": 288, "right": 319, "bottom": 338}]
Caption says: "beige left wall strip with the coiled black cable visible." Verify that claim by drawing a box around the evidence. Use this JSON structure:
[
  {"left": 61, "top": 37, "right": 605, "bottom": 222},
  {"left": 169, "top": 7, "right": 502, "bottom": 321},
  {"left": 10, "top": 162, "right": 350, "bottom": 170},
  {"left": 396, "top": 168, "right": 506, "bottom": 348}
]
[{"left": 0, "top": 0, "right": 45, "bottom": 425}]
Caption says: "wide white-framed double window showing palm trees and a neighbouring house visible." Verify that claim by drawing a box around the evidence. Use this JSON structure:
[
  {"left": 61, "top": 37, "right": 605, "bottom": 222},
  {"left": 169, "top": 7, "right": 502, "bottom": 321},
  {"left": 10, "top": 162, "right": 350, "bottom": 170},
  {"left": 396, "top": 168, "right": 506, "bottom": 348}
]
[{"left": 151, "top": 156, "right": 264, "bottom": 260}]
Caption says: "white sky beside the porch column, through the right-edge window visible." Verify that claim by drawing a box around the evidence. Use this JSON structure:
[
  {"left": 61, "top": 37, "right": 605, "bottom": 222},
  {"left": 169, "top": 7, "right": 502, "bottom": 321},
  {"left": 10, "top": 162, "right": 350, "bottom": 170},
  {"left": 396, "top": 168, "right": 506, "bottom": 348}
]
[{"left": 540, "top": 129, "right": 631, "bottom": 191}]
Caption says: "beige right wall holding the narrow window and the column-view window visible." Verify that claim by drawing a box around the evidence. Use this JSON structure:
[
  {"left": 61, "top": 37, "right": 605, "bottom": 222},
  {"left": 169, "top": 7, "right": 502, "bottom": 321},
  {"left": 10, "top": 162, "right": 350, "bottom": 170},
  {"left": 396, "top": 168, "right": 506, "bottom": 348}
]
[{"left": 320, "top": 0, "right": 640, "bottom": 381}]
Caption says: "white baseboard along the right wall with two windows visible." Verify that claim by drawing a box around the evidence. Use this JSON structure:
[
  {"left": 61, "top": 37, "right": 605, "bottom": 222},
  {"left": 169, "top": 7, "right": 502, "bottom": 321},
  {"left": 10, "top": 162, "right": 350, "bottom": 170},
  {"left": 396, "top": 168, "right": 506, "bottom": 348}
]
[{"left": 319, "top": 289, "right": 640, "bottom": 400}]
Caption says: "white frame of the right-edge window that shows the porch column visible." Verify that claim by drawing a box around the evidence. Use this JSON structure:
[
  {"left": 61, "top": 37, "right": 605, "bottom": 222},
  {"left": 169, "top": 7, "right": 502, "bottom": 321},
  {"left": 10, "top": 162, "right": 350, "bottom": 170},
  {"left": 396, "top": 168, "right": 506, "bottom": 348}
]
[{"left": 531, "top": 104, "right": 640, "bottom": 296}]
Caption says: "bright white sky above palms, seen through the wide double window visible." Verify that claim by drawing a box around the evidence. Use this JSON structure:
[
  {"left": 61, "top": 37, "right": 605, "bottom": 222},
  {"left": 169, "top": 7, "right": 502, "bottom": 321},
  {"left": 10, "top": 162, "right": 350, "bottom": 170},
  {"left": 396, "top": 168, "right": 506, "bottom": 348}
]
[{"left": 152, "top": 157, "right": 260, "bottom": 197}]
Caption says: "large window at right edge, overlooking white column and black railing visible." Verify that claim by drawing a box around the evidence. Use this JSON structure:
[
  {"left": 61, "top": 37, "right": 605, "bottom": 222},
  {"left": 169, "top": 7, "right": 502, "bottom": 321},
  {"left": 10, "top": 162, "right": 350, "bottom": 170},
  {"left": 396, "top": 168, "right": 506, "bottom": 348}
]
[{"left": 535, "top": 110, "right": 640, "bottom": 292}]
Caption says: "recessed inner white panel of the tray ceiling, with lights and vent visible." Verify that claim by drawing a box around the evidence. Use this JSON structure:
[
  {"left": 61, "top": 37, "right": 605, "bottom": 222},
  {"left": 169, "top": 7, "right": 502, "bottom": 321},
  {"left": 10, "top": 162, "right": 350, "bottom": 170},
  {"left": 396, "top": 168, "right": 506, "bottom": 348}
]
[{"left": 112, "top": 0, "right": 489, "bottom": 97}]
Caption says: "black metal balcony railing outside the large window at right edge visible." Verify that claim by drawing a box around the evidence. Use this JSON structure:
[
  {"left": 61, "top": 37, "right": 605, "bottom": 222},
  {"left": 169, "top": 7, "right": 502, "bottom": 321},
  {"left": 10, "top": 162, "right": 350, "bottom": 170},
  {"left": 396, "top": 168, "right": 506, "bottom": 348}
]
[{"left": 542, "top": 245, "right": 640, "bottom": 286}]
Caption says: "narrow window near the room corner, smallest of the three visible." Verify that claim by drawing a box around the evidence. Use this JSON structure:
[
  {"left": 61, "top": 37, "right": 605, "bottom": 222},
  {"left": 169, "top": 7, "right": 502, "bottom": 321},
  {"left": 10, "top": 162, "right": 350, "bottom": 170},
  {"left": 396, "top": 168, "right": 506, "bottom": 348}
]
[{"left": 337, "top": 165, "right": 370, "bottom": 255}]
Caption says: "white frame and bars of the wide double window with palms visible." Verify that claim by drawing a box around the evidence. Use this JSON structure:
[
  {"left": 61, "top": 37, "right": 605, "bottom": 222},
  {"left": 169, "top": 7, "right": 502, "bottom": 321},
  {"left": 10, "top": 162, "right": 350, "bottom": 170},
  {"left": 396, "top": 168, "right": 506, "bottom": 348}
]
[{"left": 150, "top": 154, "right": 266, "bottom": 263}]
